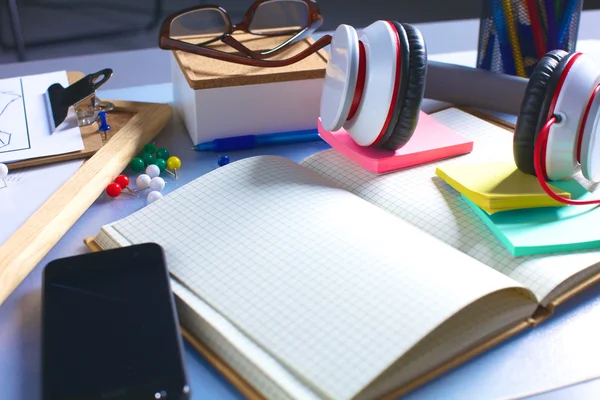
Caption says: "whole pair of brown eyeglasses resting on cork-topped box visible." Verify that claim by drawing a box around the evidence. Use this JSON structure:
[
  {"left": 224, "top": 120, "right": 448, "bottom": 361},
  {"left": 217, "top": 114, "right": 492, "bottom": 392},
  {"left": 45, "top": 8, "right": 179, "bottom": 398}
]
[{"left": 159, "top": 0, "right": 331, "bottom": 67}]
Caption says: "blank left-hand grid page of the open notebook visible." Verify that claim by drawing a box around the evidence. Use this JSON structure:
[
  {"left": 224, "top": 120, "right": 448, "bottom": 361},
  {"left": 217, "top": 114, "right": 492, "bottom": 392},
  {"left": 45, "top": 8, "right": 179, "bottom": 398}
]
[{"left": 103, "top": 157, "right": 525, "bottom": 399}]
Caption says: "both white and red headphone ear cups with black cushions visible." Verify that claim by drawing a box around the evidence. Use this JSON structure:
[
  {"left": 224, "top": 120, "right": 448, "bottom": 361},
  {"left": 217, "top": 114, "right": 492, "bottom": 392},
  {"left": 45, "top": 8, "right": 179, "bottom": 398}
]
[{"left": 320, "top": 21, "right": 600, "bottom": 204}]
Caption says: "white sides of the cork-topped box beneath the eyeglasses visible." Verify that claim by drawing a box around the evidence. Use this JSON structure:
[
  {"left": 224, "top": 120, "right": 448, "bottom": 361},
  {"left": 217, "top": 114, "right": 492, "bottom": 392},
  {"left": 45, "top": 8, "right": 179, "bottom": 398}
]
[{"left": 171, "top": 51, "right": 325, "bottom": 144}]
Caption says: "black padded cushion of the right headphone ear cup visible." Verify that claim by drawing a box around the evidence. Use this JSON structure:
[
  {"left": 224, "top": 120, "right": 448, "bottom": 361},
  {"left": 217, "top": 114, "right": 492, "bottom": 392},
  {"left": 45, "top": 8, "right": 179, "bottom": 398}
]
[{"left": 513, "top": 50, "right": 569, "bottom": 175}]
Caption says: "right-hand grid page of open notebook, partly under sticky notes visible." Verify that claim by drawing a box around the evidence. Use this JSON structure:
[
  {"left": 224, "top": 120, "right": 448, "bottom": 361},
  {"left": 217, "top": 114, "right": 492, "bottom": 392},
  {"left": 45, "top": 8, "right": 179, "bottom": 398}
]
[{"left": 301, "top": 108, "right": 600, "bottom": 305}]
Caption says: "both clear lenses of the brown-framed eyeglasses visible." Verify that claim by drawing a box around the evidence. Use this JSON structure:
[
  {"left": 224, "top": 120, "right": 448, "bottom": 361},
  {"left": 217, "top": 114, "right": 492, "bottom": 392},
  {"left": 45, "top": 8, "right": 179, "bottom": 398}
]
[{"left": 170, "top": 0, "right": 309, "bottom": 44}]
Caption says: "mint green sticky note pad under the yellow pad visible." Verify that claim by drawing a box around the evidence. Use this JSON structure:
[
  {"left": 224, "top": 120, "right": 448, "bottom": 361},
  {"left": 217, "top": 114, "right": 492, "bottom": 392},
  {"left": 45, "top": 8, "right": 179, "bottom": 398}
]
[{"left": 461, "top": 180, "right": 600, "bottom": 257}]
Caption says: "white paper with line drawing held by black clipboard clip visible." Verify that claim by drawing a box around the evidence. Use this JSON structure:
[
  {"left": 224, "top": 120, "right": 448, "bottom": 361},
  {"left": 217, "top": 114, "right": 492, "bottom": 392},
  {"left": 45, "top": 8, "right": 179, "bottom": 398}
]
[{"left": 0, "top": 71, "right": 83, "bottom": 163}]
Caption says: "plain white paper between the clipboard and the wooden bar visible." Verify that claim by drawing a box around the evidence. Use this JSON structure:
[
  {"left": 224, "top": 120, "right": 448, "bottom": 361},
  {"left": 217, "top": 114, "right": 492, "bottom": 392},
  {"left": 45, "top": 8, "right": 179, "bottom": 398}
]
[{"left": 0, "top": 160, "right": 83, "bottom": 246}]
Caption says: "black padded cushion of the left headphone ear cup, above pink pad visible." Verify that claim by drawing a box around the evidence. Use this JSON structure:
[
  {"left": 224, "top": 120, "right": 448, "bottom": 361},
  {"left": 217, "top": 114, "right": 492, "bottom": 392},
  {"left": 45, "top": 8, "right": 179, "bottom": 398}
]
[{"left": 378, "top": 22, "right": 427, "bottom": 150}]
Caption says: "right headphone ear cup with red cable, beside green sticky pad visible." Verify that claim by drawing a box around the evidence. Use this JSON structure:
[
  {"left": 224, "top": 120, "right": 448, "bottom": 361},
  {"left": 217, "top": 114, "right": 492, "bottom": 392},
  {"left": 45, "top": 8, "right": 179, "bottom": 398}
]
[{"left": 513, "top": 50, "right": 600, "bottom": 204}]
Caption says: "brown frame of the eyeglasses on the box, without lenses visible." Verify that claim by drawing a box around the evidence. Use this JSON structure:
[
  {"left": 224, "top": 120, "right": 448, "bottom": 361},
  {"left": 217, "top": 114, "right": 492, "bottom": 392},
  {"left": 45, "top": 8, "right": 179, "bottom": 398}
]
[{"left": 158, "top": 0, "right": 331, "bottom": 67}]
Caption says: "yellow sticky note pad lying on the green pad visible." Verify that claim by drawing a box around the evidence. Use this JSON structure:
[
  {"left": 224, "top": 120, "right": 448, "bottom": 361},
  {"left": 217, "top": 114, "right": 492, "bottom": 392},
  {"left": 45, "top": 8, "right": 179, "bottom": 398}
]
[{"left": 435, "top": 162, "right": 571, "bottom": 214}]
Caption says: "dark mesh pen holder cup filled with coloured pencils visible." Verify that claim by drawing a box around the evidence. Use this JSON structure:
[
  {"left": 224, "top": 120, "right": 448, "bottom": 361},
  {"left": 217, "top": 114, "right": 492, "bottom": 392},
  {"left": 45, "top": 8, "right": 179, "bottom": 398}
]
[{"left": 477, "top": 0, "right": 583, "bottom": 78}]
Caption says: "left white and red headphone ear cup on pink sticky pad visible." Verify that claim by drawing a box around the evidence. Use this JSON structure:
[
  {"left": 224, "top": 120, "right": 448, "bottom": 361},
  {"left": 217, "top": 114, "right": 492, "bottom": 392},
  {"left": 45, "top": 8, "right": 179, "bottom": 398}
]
[{"left": 321, "top": 21, "right": 427, "bottom": 150}]
